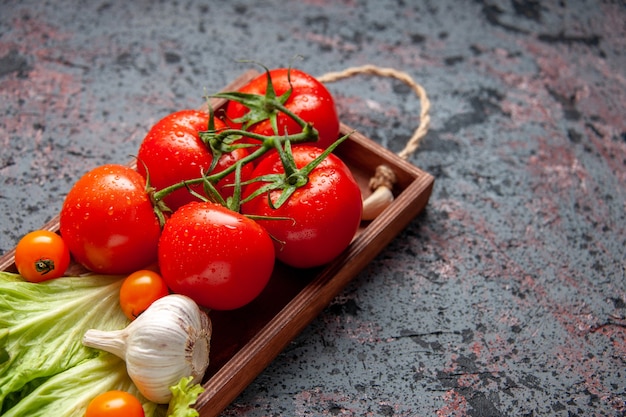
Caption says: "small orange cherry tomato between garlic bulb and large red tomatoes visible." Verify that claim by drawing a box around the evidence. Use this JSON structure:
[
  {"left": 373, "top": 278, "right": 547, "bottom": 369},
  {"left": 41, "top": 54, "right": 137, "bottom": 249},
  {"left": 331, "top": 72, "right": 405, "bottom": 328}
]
[{"left": 120, "top": 269, "right": 169, "bottom": 320}]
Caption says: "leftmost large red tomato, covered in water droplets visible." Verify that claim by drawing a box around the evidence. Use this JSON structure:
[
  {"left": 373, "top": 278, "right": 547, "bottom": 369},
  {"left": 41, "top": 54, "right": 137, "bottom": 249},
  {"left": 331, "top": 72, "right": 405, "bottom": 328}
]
[{"left": 60, "top": 164, "right": 161, "bottom": 274}]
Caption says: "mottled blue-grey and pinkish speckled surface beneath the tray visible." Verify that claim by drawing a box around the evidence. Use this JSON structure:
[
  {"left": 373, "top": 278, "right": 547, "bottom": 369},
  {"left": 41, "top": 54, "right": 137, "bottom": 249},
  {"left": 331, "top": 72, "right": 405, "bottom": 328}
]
[{"left": 0, "top": 0, "right": 626, "bottom": 416}]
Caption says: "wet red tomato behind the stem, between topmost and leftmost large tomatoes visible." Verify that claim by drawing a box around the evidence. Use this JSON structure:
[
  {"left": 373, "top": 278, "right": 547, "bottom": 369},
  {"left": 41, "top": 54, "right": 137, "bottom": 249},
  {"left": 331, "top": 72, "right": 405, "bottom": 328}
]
[{"left": 137, "top": 110, "right": 252, "bottom": 210}]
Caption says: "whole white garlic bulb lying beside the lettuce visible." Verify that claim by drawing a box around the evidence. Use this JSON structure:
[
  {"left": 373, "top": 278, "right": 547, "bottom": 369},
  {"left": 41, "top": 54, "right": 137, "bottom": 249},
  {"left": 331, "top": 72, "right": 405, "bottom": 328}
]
[{"left": 83, "top": 294, "right": 211, "bottom": 404}]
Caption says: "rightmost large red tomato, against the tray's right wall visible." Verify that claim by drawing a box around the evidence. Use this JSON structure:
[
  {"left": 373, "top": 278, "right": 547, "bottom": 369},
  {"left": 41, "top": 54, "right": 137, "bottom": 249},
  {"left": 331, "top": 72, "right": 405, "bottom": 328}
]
[{"left": 242, "top": 145, "right": 363, "bottom": 268}]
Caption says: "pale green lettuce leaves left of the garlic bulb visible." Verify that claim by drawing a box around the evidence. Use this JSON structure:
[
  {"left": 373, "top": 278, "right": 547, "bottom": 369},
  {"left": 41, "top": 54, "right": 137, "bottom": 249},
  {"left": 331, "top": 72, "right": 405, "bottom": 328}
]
[{"left": 0, "top": 272, "right": 165, "bottom": 417}]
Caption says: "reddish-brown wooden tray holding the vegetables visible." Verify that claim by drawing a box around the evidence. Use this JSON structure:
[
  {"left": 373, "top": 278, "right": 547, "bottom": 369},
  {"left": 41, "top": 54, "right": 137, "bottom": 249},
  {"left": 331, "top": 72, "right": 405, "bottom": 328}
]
[{"left": 0, "top": 71, "right": 434, "bottom": 417}]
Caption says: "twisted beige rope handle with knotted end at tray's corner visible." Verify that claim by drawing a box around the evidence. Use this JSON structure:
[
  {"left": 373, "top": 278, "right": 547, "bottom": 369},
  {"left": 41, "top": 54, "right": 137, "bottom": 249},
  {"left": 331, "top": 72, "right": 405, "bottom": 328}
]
[{"left": 317, "top": 64, "right": 430, "bottom": 220}]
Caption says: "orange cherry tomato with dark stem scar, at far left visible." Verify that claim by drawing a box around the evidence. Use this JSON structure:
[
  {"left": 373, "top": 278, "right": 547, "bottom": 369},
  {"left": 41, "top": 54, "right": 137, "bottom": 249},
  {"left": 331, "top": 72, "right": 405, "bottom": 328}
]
[{"left": 15, "top": 230, "right": 70, "bottom": 282}]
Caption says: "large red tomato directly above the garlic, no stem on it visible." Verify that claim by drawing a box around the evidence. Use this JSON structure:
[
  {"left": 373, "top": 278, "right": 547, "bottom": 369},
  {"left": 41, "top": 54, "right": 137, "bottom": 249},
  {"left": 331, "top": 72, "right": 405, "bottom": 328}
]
[{"left": 159, "top": 202, "right": 275, "bottom": 310}]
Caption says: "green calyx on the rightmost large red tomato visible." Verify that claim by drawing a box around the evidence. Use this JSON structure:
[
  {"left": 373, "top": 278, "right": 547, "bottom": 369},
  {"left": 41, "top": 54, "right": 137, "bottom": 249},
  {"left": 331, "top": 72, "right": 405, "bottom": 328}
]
[{"left": 241, "top": 133, "right": 350, "bottom": 209}]
